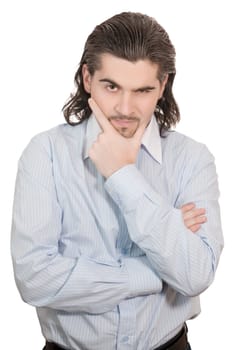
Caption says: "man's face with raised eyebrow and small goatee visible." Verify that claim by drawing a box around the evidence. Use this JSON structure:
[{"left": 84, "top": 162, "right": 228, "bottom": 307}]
[{"left": 83, "top": 54, "right": 167, "bottom": 137}]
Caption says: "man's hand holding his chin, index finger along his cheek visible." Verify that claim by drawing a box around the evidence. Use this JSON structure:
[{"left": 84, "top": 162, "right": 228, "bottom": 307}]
[{"left": 89, "top": 98, "right": 146, "bottom": 178}]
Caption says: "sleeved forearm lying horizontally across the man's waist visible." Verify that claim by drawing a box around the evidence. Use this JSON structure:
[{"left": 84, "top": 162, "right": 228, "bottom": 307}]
[{"left": 13, "top": 247, "right": 162, "bottom": 313}]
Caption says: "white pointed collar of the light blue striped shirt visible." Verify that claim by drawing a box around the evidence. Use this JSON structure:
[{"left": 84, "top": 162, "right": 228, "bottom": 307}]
[{"left": 83, "top": 114, "right": 162, "bottom": 164}]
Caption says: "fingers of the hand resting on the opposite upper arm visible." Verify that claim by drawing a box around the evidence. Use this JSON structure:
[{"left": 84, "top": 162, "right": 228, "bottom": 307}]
[{"left": 181, "top": 203, "right": 207, "bottom": 233}]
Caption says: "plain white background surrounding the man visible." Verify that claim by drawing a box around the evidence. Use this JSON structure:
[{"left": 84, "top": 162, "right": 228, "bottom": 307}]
[{"left": 0, "top": 0, "right": 234, "bottom": 350}]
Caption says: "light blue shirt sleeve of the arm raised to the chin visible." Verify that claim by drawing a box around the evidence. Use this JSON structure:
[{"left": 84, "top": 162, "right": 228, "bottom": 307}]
[{"left": 106, "top": 146, "right": 223, "bottom": 296}]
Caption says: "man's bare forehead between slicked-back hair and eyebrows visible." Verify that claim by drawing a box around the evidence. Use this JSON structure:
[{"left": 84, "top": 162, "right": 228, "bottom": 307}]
[{"left": 94, "top": 54, "right": 159, "bottom": 88}]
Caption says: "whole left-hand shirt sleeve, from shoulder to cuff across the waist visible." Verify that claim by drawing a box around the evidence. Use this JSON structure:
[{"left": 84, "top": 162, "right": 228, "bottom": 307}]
[{"left": 11, "top": 137, "right": 162, "bottom": 313}]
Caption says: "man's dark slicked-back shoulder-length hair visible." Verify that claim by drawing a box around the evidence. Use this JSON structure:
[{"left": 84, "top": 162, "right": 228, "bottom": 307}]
[{"left": 63, "top": 12, "right": 180, "bottom": 135}]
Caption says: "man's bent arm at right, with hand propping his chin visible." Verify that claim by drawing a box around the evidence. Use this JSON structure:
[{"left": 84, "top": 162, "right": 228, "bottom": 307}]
[{"left": 89, "top": 99, "right": 223, "bottom": 296}]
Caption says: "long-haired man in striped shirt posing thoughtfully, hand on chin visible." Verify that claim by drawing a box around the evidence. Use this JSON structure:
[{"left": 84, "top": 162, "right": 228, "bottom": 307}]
[{"left": 12, "top": 13, "right": 223, "bottom": 350}]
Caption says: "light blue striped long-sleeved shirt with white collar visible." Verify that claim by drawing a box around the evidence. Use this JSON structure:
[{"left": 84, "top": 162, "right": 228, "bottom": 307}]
[{"left": 12, "top": 116, "right": 223, "bottom": 350}]
